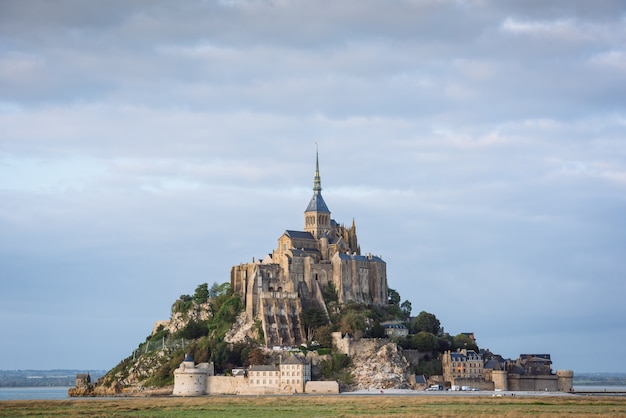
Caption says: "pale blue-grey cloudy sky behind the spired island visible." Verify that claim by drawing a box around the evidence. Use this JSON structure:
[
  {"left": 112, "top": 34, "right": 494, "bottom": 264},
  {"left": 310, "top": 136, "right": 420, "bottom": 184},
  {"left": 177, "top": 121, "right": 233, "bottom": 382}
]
[{"left": 0, "top": 0, "right": 626, "bottom": 372}]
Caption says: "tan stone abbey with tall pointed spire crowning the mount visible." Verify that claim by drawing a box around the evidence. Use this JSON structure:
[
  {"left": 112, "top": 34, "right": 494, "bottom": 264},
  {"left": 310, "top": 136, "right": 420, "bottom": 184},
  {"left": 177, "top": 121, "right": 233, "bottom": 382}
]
[{"left": 230, "top": 154, "right": 388, "bottom": 347}]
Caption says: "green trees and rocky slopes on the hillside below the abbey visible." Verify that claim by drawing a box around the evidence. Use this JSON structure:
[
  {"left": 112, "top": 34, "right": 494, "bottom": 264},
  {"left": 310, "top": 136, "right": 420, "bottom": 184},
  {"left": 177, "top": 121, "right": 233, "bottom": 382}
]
[{"left": 88, "top": 283, "right": 468, "bottom": 396}]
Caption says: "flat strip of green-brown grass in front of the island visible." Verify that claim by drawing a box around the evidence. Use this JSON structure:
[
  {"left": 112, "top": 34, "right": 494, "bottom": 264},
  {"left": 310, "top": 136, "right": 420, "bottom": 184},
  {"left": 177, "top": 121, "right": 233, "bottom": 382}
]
[{"left": 0, "top": 395, "right": 626, "bottom": 418}]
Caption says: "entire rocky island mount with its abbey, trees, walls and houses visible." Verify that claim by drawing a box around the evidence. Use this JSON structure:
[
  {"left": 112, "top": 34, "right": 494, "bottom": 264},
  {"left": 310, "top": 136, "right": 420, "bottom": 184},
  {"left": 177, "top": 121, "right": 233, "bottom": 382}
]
[{"left": 69, "top": 155, "right": 573, "bottom": 396}]
